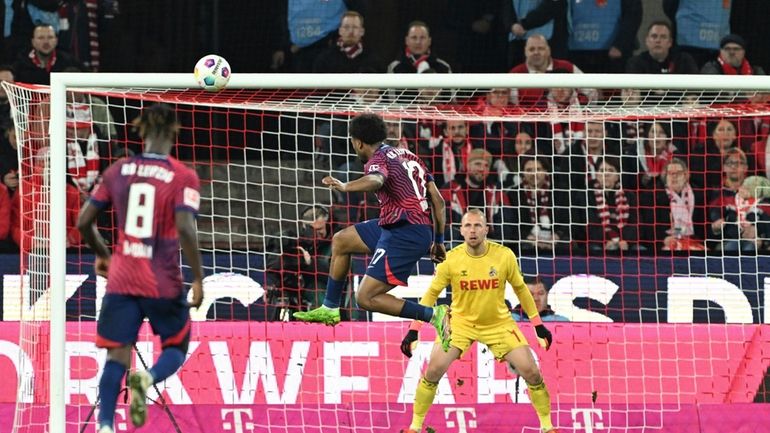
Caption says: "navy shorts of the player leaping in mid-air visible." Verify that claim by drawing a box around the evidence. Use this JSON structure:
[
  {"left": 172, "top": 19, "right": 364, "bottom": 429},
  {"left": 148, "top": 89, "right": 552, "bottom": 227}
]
[{"left": 355, "top": 219, "right": 433, "bottom": 286}]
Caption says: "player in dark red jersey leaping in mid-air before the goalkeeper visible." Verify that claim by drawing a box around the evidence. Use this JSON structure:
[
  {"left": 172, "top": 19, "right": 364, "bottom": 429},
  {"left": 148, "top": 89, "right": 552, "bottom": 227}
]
[{"left": 294, "top": 114, "right": 450, "bottom": 350}]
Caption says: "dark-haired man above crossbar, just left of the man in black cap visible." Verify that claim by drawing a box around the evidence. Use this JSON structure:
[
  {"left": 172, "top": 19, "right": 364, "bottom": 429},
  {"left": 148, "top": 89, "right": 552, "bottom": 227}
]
[{"left": 626, "top": 21, "right": 698, "bottom": 74}]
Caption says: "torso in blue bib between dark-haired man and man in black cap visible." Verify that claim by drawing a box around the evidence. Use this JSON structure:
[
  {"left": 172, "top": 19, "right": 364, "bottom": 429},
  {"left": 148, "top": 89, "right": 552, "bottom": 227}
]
[{"left": 663, "top": 0, "right": 732, "bottom": 68}]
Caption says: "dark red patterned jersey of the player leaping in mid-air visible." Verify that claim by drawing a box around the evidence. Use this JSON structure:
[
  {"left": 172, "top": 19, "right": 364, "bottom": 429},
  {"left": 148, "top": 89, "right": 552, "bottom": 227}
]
[{"left": 364, "top": 144, "right": 433, "bottom": 225}]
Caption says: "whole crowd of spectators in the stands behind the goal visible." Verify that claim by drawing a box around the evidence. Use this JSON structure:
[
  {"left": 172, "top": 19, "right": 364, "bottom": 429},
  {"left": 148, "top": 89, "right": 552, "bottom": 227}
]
[{"left": 0, "top": 0, "right": 770, "bottom": 314}]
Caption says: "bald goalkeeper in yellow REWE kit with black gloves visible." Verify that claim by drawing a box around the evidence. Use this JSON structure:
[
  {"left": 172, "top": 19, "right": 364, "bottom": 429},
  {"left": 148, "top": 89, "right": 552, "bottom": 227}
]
[{"left": 401, "top": 209, "right": 558, "bottom": 433}]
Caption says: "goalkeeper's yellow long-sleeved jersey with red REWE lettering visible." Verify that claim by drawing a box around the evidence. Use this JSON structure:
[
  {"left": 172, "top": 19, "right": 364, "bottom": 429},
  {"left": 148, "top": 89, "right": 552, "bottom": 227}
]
[{"left": 420, "top": 241, "right": 538, "bottom": 326}]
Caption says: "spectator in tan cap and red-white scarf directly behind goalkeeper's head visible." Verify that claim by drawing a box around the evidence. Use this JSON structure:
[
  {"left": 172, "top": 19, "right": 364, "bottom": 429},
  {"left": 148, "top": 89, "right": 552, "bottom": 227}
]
[{"left": 441, "top": 149, "right": 510, "bottom": 242}]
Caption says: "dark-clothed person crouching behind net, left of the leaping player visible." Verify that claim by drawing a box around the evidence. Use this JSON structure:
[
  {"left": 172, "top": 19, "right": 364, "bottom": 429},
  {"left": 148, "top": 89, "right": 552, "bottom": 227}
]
[{"left": 265, "top": 205, "right": 334, "bottom": 316}]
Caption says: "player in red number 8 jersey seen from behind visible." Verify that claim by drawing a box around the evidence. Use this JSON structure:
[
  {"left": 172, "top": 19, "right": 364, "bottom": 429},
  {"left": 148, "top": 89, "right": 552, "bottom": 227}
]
[{"left": 78, "top": 105, "right": 203, "bottom": 433}]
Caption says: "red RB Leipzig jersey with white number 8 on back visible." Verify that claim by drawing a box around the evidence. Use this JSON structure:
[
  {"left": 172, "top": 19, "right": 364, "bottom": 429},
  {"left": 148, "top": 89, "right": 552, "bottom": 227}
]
[{"left": 90, "top": 154, "right": 200, "bottom": 299}]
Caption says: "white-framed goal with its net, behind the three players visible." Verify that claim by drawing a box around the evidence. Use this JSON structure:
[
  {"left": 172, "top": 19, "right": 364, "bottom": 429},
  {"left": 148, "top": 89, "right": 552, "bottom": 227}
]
[{"left": 6, "top": 74, "right": 770, "bottom": 433}]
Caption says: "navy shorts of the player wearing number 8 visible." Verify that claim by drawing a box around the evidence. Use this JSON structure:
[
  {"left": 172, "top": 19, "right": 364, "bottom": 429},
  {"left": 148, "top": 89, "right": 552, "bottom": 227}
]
[{"left": 96, "top": 293, "right": 190, "bottom": 349}]
